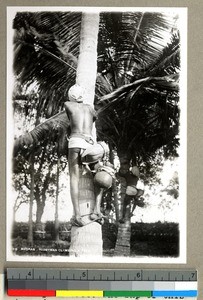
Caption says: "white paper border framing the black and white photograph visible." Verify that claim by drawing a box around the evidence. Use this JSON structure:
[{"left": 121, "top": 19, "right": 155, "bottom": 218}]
[{"left": 6, "top": 6, "right": 187, "bottom": 264}]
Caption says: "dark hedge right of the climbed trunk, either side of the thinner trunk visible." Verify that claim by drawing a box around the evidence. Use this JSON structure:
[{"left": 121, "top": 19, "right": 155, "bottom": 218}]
[{"left": 103, "top": 222, "right": 179, "bottom": 257}]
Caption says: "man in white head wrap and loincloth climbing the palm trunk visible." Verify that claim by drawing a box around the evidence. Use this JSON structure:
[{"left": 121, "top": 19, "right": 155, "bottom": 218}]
[{"left": 65, "top": 84, "right": 113, "bottom": 226}]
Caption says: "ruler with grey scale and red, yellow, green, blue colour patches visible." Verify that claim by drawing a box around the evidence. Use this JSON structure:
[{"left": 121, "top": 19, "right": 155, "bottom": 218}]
[{"left": 7, "top": 269, "right": 198, "bottom": 298}]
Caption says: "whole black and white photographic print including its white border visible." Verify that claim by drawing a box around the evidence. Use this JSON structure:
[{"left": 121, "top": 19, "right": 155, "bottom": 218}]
[{"left": 6, "top": 6, "right": 187, "bottom": 263}]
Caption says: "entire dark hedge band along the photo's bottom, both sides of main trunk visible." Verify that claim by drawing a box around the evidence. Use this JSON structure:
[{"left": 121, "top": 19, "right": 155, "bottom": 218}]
[{"left": 12, "top": 222, "right": 179, "bottom": 257}]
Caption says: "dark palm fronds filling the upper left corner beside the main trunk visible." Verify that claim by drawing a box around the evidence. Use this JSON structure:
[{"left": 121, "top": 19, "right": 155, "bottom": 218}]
[{"left": 13, "top": 12, "right": 81, "bottom": 117}]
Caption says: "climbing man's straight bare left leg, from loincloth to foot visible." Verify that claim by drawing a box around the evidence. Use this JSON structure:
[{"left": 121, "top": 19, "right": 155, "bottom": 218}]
[{"left": 68, "top": 148, "right": 85, "bottom": 226}]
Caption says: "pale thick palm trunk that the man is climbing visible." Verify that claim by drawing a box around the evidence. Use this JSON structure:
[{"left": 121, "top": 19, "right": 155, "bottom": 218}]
[{"left": 69, "top": 13, "right": 102, "bottom": 257}]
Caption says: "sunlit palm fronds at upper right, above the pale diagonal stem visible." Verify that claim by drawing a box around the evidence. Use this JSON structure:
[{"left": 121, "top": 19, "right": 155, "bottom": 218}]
[{"left": 98, "top": 11, "right": 179, "bottom": 88}]
